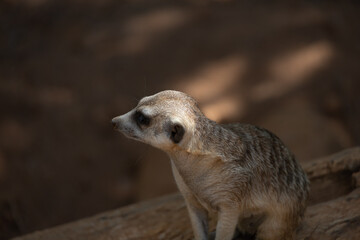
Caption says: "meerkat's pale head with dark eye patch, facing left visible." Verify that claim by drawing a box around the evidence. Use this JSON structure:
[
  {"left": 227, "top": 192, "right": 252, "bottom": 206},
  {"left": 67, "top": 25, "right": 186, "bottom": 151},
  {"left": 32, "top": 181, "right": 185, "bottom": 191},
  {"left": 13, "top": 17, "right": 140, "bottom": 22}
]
[{"left": 112, "top": 90, "right": 202, "bottom": 151}]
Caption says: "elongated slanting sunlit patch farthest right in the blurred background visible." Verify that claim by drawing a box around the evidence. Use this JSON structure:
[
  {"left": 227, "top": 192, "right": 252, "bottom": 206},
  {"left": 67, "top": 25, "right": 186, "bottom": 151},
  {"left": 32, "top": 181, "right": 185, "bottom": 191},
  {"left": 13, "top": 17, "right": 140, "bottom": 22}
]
[{"left": 251, "top": 41, "right": 334, "bottom": 101}]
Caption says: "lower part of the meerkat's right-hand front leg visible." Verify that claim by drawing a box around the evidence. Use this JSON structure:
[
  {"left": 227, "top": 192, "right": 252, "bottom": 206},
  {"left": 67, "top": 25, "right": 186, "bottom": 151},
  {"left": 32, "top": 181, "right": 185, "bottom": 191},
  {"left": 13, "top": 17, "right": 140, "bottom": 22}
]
[{"left": 215, "top": 208, "right": 239, "bottom": 240}]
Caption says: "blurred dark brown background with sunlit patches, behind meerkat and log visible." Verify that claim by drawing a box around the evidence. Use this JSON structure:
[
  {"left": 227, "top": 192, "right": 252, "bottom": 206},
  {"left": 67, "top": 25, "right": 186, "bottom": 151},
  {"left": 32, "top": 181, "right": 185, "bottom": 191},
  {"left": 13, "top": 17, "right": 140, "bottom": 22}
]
[{"left": 0, "top": 0, "right": 360, "bottom": 239}]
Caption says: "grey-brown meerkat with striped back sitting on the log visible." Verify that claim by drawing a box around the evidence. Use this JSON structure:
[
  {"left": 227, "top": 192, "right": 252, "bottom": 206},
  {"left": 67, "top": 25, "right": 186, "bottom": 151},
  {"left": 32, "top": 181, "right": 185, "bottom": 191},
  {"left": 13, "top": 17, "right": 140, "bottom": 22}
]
[{"left": 112, "top": 90, "right": 309, "bottom": 240}]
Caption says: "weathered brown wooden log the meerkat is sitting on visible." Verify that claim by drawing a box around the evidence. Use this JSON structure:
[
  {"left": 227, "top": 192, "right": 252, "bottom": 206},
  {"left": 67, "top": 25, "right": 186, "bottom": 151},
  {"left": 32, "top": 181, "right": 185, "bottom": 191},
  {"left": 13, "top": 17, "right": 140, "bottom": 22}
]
[{"left": 15, "top": 148, "right": 360, "bottom": 240}]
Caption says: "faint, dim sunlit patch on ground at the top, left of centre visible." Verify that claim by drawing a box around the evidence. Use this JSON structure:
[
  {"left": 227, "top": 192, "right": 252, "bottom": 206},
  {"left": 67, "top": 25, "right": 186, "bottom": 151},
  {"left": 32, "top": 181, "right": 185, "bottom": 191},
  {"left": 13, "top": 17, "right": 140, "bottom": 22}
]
[{"left": 119, "top": 8, "right": 189, "bottom": 54}]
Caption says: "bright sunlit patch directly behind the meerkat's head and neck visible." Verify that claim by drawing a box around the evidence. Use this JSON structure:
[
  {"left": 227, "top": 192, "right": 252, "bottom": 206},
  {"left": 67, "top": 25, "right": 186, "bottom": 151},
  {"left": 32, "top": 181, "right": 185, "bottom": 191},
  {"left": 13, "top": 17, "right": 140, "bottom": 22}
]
[{"left": 176, "top": 56, "right": 247, "bottom": 121}]
